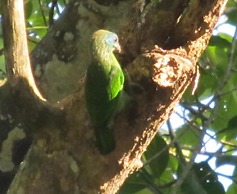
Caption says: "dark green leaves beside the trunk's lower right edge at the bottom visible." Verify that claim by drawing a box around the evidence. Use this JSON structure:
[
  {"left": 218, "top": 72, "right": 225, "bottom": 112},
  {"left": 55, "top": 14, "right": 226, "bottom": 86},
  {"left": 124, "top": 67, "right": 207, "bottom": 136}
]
[{"left": 120, "top": 135, "right": 169, "bottom": 194}]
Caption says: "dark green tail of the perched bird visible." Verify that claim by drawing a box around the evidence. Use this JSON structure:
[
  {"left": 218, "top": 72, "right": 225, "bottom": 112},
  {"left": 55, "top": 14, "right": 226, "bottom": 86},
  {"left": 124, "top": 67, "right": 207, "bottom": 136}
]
[{"left": 95, "top": 128, "right": 116, "bottom": 155}]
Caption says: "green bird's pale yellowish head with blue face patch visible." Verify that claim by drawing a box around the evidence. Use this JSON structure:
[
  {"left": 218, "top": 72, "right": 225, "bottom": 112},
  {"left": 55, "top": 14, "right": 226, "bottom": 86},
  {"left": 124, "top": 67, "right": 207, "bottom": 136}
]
[{"left": 92, "top": 30, "right": 121, "bottom": 52}]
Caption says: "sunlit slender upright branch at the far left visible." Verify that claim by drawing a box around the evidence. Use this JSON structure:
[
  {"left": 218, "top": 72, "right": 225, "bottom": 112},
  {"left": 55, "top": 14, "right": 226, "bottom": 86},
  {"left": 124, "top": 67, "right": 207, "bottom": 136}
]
[{"left": 2, "top": 0, "right": 45, "bottom": 101}]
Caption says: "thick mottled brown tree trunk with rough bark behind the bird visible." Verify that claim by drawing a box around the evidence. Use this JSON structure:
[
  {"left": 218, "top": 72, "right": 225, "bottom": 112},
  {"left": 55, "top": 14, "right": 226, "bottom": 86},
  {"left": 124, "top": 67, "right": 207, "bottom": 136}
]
[{"left": 0, "top": 0, "right": 229, "bottom": 194}]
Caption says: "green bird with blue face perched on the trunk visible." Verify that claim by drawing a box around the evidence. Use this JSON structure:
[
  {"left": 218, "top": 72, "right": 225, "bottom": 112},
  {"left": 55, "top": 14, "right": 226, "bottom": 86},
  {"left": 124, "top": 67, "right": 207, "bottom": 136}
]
[{"left": 85, "top": 30, "right": 129, "bottom": 155}]
